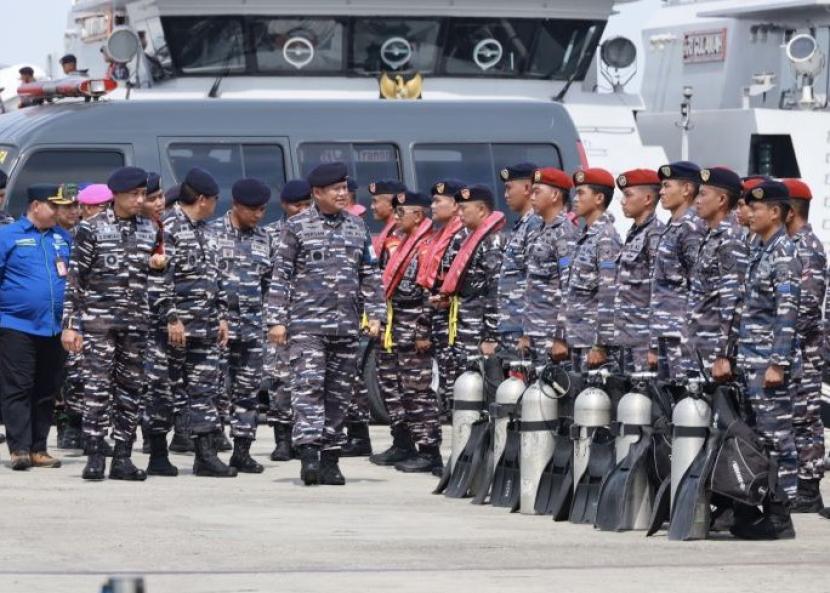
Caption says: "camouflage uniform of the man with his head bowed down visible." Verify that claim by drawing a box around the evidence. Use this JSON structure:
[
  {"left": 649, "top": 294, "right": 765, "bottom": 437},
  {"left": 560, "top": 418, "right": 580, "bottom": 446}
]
[{"left": 210, "top": 212, "right": 273, "bottom": 439}]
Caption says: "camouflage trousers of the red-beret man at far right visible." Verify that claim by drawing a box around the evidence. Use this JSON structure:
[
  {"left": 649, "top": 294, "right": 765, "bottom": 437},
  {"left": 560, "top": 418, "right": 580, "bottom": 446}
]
[{"left": 792, "top": 334, "right": 824, "bottom": 480}]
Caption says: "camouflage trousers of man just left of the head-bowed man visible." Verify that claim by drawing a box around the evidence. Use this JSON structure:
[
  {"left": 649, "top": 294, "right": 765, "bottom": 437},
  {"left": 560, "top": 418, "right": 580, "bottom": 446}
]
[{"left": 167, "top": 337, "right": 224, "bottom": 436}]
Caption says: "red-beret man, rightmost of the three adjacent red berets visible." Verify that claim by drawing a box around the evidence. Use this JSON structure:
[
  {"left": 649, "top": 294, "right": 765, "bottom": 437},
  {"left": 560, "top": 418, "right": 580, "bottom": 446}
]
[{"left": 614, "top": 169, "right": 665, "bottom": 373}]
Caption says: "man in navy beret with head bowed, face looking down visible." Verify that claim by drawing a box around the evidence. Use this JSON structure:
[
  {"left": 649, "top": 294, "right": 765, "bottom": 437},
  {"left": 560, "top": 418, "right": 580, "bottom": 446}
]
[{"left": 210, "top": 178, "right": 273, "bottom": 474}]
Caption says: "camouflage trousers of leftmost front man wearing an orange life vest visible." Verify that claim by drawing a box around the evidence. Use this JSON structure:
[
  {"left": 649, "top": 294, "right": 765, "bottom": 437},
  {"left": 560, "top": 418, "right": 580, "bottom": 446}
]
[{"left": 378, "top": 350, "right": 441, "bottom": 447}]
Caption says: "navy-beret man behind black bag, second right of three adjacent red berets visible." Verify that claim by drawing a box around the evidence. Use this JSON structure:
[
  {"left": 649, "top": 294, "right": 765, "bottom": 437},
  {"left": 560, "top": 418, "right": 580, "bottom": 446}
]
[{"left": 687, "top": 167, "right": 749, "bottom": 381}]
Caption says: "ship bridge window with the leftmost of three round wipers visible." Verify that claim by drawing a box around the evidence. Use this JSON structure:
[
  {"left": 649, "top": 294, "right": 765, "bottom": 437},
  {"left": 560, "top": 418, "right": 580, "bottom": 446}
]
[{"left": 250, "top": 17, "right": 344, "bottom": 74}]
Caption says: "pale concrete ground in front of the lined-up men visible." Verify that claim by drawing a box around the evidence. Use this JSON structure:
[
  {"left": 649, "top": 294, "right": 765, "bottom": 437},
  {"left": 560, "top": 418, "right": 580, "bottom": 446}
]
[{"left": 0, "top": 427, "right": 830, "bottom": 593}]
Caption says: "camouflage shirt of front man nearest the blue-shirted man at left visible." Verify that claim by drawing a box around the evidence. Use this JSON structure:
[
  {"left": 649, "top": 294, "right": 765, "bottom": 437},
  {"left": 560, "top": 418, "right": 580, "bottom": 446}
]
[{"left": 63, "top": 208, "right": 163, "bottom": 333}]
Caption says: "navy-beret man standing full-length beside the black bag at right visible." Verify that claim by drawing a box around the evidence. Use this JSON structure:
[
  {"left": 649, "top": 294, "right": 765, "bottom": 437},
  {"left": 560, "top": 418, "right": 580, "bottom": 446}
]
[{"left": 731, "top": 181, "right": 801, "bottom": 539}]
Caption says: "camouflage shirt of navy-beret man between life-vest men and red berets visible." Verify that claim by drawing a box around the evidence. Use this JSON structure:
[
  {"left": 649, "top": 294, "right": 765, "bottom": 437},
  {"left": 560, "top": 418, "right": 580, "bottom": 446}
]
[{"left": 498, "top": 210, "right": 542, "bottom": 334}]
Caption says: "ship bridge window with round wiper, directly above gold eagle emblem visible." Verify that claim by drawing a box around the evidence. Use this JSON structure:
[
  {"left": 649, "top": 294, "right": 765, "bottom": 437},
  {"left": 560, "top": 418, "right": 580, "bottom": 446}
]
[{"left": 349, "top": 18, "right": 441, "bottom": 75}]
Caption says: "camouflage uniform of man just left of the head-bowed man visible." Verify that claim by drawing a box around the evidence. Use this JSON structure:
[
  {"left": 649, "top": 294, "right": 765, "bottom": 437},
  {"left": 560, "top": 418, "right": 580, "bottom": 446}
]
[{"left": 156, "top": 204, "right": 228, "bottom": 436}]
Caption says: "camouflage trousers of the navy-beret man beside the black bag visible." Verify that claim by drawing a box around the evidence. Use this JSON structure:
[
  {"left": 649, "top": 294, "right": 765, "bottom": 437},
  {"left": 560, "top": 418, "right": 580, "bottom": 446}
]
[{"left": 743, "top": 367, "right": 798, "bottom": 498}]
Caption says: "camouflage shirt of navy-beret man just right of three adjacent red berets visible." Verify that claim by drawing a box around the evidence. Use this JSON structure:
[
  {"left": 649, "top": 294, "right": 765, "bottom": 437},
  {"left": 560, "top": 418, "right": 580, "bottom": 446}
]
[{"left": 649, "top": 208, "right": 706, "bottom": 349}]
